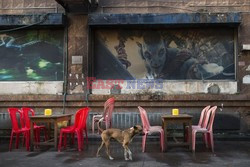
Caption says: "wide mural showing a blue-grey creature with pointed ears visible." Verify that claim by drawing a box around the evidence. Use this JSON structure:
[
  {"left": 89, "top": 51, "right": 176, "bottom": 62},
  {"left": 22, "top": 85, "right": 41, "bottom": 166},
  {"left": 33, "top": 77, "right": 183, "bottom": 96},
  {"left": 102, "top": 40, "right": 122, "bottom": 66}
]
[{"left": 94, "top": 28, "right": 235, "bottom": 80}]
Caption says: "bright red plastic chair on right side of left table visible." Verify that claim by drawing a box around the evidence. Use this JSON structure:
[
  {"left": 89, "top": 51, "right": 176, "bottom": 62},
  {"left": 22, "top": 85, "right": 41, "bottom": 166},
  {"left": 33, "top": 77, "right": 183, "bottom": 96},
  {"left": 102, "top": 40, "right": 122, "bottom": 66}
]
[{"left": 58, "top": 107, "right": 90, "bottom": 152}]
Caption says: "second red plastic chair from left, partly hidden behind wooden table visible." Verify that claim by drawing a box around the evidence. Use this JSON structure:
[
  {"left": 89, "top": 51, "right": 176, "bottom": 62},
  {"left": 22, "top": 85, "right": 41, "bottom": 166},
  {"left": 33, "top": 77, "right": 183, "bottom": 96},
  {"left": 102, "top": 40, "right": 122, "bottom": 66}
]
[{"left": 21, "top": 107, "right": 48, "bottom": 142}]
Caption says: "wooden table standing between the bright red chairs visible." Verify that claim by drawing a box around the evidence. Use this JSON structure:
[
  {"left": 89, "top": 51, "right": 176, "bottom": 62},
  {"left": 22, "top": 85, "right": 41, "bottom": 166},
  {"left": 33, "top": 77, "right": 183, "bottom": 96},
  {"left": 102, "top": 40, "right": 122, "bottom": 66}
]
[{"left": 30, "top": 114, "right": 72, "bottom": 151}]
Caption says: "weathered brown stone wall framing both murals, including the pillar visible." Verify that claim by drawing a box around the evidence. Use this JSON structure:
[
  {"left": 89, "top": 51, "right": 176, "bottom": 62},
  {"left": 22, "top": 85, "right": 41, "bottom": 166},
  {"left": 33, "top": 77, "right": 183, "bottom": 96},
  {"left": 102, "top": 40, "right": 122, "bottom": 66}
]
[{"left": 0, "top": 0, "right": 250, "bottom": 132}]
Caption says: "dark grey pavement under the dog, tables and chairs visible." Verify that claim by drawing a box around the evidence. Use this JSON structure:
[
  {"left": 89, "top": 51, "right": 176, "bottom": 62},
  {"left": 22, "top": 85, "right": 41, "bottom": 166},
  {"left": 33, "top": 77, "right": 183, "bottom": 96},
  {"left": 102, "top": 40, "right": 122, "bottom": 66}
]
[{"left": 0, "top": 138, "right": 250, "bottom": 167}]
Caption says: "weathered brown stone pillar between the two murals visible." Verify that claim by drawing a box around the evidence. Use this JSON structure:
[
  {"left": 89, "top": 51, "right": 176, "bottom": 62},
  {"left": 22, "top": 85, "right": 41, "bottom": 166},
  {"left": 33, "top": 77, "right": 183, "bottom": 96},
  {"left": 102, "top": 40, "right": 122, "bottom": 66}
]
[{"left": 67, "top": 15, "right": 88, "bottom": 94}]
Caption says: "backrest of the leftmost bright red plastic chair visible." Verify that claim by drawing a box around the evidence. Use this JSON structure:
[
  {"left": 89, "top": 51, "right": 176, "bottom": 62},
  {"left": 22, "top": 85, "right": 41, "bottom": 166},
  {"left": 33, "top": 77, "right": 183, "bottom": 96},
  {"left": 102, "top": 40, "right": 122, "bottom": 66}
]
[{"left": 8, "top": 108, "right": 24, "bottom": 131}]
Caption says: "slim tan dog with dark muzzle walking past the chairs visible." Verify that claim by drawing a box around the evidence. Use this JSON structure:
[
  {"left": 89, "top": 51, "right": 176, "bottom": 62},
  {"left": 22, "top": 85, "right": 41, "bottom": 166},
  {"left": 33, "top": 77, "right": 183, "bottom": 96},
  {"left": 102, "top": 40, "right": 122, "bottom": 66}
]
[{"left": 96, "top": 124, "right": 142, "bottom": 161}]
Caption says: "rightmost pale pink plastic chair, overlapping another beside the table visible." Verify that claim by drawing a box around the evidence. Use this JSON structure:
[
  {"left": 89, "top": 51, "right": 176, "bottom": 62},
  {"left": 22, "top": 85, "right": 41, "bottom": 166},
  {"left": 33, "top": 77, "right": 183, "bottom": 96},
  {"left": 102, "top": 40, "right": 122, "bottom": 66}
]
[{"left": 192, "top": 106, "right": 217, "bottom": 152}]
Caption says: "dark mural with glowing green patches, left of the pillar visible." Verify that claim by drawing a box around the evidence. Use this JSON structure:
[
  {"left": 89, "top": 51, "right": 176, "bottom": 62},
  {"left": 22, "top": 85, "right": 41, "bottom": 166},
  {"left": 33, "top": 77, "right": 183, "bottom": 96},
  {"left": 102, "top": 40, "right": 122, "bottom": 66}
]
[{"left": 0, "top": 29, "right": 63, "bottom": 81}]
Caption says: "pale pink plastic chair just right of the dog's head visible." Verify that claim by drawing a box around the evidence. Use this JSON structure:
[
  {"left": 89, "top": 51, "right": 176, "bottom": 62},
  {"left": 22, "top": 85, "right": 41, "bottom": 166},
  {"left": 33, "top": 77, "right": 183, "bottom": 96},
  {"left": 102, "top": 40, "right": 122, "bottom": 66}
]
[{"left": 138, "top": 106, "right": 165, "bottom": 152}]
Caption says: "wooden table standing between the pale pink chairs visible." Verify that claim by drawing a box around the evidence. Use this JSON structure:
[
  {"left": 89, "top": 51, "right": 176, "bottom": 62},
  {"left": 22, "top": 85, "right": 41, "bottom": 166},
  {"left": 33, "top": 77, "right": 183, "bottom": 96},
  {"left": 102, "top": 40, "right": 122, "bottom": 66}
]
[{"left": 161, "top": 114, "right": 193, "bottom": 151}]
